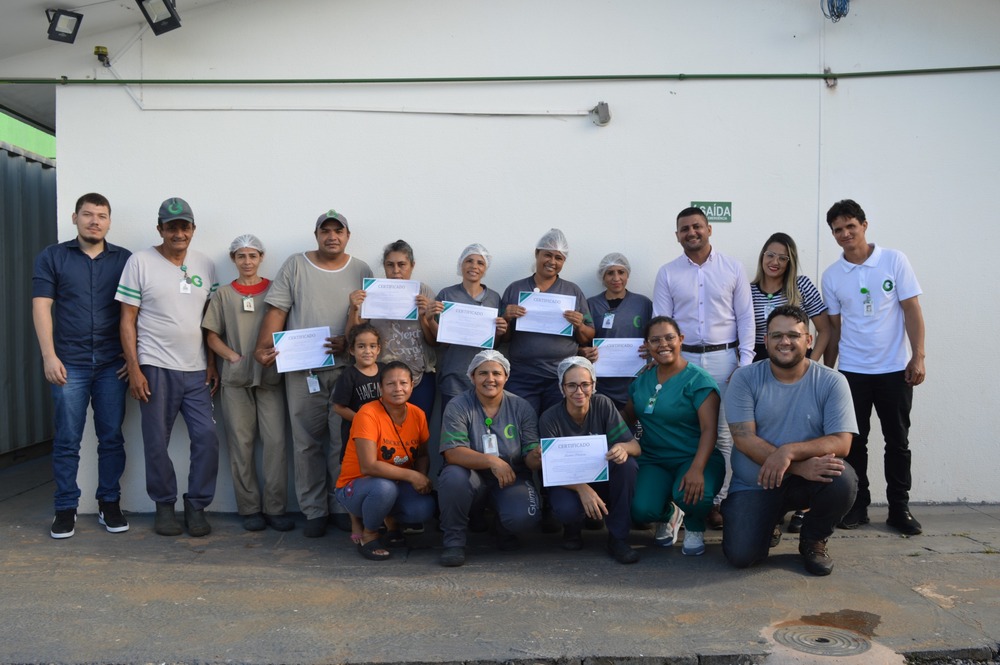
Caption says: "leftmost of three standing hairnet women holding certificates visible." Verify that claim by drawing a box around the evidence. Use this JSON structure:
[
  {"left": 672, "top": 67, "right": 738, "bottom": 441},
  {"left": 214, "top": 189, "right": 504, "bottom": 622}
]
[{"left": 427, "top": 243, "right": 507, "bottom": 413}]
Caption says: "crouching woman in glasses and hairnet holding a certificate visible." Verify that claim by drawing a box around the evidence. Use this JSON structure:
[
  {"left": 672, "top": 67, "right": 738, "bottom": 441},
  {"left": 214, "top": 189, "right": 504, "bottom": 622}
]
[{"left": 538, "top": 356, "right": 641, "bottom": 563}]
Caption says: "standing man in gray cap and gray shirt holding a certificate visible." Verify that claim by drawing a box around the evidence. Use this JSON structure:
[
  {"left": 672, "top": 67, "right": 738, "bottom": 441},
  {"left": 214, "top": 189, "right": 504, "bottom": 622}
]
[{"left": 254, "top": 210, "right": 372, "bottom": 538}]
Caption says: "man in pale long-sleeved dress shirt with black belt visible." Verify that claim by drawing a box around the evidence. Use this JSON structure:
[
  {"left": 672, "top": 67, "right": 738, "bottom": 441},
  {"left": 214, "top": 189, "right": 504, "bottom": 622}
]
[{"left": 653, "top": 207, "right": 756, "bottom": 529}]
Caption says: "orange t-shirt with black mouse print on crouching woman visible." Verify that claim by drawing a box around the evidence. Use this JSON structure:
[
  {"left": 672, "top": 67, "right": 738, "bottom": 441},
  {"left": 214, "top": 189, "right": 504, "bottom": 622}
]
[{"left": 337, "top": 400, "right": 431, "bottom": 487}]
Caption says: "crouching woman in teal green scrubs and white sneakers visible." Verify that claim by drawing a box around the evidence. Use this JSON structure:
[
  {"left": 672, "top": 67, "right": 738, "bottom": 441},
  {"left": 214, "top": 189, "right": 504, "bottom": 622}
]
[{"left": 625, "top": 316, "right": 726, "bottom": 556}]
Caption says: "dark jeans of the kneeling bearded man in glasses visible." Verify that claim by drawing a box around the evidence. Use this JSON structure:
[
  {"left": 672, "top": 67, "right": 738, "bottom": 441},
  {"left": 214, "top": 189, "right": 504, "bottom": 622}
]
[{"left": 722, "top": 464, "right": 858, "bottom": 568}]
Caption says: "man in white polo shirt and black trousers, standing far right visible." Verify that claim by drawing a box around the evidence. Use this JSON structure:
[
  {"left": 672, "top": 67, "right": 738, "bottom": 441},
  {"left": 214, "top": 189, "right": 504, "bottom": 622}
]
[{"left": 823, "top": 199, "right": 926, "bottom": 536}]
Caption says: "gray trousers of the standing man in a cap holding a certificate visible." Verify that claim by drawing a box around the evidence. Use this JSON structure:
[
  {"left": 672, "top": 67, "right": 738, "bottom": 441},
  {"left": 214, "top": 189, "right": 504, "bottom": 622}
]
[{"left": 285, "top": 366, "right": 344, "bottom": 519}]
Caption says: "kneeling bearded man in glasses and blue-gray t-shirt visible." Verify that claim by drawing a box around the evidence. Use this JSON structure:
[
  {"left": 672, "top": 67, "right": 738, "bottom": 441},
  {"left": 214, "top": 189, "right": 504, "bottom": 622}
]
[{"left": 722, "top": 305, "right": 858, "bottom": 575}]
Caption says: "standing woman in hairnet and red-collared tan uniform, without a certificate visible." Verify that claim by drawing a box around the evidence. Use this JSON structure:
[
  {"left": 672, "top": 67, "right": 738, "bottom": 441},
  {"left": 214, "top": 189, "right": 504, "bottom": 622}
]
[{"left": 201, "top": 233, "right": 295, "bottom": 531}]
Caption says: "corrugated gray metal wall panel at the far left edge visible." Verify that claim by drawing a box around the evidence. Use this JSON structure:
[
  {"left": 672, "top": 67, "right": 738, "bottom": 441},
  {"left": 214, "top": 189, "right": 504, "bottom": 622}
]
[{"left": 0, "top": 145, "right": 57, "bottom": 454}]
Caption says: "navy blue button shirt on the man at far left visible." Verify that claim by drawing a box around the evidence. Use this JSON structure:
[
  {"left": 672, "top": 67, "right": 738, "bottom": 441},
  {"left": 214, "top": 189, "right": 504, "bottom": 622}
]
[{"left": 31, "top": 238, "right": 132, "bottom": 365}]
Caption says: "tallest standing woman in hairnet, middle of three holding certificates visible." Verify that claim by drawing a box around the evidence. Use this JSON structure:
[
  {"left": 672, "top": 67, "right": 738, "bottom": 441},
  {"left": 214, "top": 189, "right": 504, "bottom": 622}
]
[{"left": 501, "top": 229, "right": 594, "bottom": 413}]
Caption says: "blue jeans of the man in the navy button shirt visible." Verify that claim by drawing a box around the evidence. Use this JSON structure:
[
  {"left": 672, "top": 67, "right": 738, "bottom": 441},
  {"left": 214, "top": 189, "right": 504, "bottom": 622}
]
[{"left": 52, "top": 361, "right": 128, "bottom": 510}]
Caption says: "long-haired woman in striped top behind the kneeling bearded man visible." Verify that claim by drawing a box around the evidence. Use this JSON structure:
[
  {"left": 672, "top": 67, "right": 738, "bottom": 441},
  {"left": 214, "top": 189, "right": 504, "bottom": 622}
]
[{"left": 750, "top": 233, "right": 830, "bottom": 362}]
